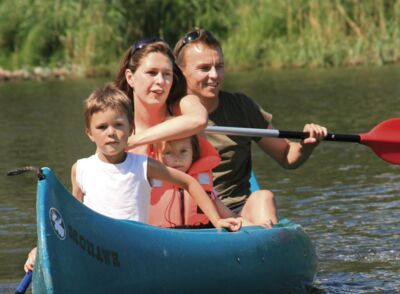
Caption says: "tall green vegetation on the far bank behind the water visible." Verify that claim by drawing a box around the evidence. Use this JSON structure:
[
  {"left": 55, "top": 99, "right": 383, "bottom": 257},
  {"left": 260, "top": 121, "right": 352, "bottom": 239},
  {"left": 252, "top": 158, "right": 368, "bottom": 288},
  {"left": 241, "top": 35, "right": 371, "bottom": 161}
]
[{"left": 0, "top": 0, "right": 400, "bottom": 76}]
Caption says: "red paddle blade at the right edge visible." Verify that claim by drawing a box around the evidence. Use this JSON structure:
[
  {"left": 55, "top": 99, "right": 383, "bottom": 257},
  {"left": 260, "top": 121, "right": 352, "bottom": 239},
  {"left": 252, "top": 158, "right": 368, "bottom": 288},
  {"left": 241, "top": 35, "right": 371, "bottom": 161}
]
[{"left": 360, "top": 118, "right": 400, "bottom": 164}]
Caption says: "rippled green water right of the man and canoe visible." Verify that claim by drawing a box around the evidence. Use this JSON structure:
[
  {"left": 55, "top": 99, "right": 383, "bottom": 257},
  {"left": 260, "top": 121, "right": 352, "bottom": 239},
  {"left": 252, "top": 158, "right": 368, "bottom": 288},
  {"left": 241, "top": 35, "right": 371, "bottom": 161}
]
[{"left": 226, "top": 67, "right": 400, "bottom": 293}]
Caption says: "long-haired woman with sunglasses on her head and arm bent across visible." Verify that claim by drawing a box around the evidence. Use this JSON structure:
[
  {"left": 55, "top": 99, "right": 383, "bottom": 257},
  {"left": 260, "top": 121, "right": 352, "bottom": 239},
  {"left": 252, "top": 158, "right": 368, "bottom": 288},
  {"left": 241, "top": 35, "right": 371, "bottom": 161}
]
[{"left": 115, "top": 38, "right": 208, "bottom": 153}]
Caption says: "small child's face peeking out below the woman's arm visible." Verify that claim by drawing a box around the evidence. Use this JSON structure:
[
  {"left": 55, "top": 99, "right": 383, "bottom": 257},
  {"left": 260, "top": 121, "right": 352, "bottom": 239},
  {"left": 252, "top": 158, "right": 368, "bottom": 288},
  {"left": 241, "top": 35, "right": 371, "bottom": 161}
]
[{"left": 161, "top": 138, "right": 193, "bottom": 172}]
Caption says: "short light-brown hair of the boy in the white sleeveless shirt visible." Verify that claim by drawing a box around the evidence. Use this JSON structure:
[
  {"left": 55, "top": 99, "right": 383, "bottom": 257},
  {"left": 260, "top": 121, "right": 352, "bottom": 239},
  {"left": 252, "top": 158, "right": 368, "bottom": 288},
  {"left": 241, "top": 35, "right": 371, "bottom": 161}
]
[{"left": 83, "top": 83, "right": 133, "bottom": 128}]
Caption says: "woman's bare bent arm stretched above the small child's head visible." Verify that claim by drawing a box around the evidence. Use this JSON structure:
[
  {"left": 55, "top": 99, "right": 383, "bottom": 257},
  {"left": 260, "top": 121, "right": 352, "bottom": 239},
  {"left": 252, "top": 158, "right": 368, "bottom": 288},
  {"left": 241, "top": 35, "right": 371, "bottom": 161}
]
[{"left": 128, "top": 95, "right": 208, "bottom": 149}]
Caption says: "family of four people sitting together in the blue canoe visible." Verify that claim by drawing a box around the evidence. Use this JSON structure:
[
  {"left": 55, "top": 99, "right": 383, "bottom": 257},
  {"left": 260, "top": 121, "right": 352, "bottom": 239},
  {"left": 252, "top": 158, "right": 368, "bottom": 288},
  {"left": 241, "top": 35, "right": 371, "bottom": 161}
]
[{"left": 25, "top": 29, "right": 327, "bottom": 271}]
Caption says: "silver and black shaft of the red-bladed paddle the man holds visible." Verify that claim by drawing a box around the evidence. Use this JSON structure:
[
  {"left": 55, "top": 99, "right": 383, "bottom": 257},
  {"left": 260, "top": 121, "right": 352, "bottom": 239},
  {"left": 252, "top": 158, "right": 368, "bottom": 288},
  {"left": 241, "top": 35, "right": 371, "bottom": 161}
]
[{"left": 206, "top": 126, "right": 360, "bottom": 143}]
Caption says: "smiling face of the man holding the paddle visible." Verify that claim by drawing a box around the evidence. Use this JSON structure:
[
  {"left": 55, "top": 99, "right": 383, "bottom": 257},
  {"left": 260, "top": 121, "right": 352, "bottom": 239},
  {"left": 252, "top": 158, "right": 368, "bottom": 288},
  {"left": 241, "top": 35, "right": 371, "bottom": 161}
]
[{"left": 181, "top": 44, "right": 224, "bottom": 99}]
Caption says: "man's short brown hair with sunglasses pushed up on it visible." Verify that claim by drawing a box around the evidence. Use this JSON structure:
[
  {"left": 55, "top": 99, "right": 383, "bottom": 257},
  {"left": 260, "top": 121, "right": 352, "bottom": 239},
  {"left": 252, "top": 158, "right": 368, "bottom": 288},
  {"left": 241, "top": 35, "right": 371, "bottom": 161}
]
[{"left": 174, "top": 28, "right": 222, "bottom": 65}]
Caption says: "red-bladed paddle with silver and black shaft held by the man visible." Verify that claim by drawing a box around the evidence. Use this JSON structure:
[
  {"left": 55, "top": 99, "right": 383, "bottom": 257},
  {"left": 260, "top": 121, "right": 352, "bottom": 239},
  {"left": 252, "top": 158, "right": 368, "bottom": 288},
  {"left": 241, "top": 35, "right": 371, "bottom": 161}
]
[{"left": 205, "top": 118, "right": 400, "bottom": 164}]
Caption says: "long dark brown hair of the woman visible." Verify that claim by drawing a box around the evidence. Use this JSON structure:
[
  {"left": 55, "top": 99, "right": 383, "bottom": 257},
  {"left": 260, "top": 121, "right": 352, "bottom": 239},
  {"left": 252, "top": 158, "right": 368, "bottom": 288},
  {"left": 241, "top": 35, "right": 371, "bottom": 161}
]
[{"left": 114, "top": 41, "right": 186, "bottom": 114}]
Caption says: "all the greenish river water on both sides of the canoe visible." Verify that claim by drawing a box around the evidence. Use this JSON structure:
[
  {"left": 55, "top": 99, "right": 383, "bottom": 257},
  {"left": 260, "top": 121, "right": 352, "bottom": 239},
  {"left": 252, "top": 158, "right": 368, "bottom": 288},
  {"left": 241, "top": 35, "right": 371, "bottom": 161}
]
[{"left": 0, "top": 67, "right": 400, "bottom": 293}]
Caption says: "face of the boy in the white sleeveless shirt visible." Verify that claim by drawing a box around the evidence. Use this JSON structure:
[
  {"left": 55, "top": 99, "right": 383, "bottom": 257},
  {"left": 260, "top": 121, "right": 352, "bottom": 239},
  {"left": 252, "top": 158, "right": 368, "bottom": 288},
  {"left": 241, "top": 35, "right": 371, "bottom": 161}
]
[{"left": 86, "top": 108, "right": 132, "bottom": 163}]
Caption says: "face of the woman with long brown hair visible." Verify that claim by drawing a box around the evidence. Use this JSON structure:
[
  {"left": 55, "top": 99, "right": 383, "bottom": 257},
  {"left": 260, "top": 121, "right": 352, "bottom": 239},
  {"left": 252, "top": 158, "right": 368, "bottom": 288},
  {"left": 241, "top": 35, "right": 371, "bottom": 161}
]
[{"left": 126, "top": 52, "right": 173, "bottom": 106}]
